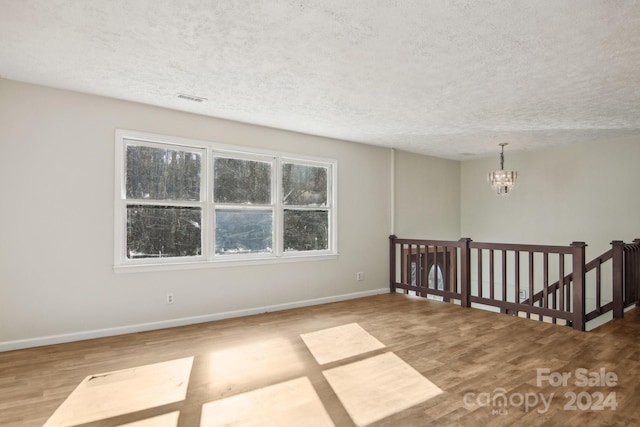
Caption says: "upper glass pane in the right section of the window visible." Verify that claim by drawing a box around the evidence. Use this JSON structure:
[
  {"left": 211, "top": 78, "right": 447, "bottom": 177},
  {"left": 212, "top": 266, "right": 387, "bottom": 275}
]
[{"left": 282, "top": 163, "right": 328, "bottom": 206}]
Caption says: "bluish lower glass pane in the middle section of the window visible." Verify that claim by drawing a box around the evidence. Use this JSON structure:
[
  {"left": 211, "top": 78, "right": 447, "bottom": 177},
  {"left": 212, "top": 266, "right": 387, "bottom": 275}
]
[{"left": 216, "top": 209, "right": 273, "bottom": 254}]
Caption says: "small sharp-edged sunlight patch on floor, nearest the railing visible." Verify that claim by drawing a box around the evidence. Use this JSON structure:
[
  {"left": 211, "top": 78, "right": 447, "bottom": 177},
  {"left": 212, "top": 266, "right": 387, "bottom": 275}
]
[{"left": 300, "top": 323, "right": 384, "bottom": 365}]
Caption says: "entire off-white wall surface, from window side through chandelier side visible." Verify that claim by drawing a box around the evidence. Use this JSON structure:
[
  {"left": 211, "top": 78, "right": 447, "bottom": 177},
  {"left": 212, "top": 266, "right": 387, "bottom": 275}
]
[{"left": 0, "top": 79, "right": 640, "bottom": 351}]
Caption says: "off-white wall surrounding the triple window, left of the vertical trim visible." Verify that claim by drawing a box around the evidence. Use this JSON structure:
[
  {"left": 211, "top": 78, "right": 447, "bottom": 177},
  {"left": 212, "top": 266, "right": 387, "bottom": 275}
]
[{"left": 0, "top": 79, "right": 391, "bottom": 350}]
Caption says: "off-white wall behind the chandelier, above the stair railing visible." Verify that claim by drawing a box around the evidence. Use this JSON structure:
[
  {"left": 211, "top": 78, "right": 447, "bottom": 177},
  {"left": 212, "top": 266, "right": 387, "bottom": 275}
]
[{"left": 461, "top": 141, "right": 640, "bottom": 260}]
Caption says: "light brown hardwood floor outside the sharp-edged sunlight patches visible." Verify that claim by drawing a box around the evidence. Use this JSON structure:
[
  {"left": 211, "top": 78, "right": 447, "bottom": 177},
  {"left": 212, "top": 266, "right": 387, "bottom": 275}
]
[{"left": 0, "top": 294, "right": 640, "bottom": 427}]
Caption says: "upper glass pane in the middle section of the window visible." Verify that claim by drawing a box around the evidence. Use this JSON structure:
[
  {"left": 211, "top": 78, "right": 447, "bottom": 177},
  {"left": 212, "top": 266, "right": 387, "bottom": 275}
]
[{"left": 213, "top": 158, "right": 271, "bottom": 205}]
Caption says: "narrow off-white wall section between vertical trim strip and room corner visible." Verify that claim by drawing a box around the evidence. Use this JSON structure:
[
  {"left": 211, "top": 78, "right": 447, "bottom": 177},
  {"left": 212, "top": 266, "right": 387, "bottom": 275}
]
[{"left": 394, "top": 151, "right": 460, "bottom": 240}]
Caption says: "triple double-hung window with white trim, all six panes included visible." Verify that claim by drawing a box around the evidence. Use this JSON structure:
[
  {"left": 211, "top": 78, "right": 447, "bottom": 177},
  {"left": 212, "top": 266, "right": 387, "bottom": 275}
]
[{"left": 114, "top": 130, "right": 337, "bottom": 267}]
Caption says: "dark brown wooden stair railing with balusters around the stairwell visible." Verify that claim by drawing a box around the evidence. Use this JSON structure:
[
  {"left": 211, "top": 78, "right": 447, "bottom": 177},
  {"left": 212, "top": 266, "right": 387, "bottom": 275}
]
[{"left": 389, "top": 236, "right": 640, "bottom": 330}]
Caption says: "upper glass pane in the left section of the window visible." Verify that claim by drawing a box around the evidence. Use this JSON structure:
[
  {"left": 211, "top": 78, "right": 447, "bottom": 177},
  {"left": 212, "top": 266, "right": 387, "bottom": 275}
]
[{"left": 126, "top": 145, "right": 201, "bottom": 200}]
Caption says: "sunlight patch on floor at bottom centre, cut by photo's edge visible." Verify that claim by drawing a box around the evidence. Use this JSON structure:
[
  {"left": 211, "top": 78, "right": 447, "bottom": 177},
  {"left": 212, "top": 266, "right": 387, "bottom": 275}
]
[{"left": 200, "top": 377, "right": 334, "bottom": 427}]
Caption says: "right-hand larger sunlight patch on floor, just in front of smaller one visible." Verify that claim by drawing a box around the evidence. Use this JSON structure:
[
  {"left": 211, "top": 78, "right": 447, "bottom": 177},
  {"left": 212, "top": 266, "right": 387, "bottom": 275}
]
[{"left": 323, "top": 353, "right": 442, "bottom": 427}]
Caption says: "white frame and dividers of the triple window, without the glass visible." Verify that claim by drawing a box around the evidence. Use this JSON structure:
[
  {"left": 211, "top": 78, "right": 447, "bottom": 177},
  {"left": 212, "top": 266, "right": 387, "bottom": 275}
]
[{"left": 113, "top": 129, "right": 338, "bottom": 272}]
